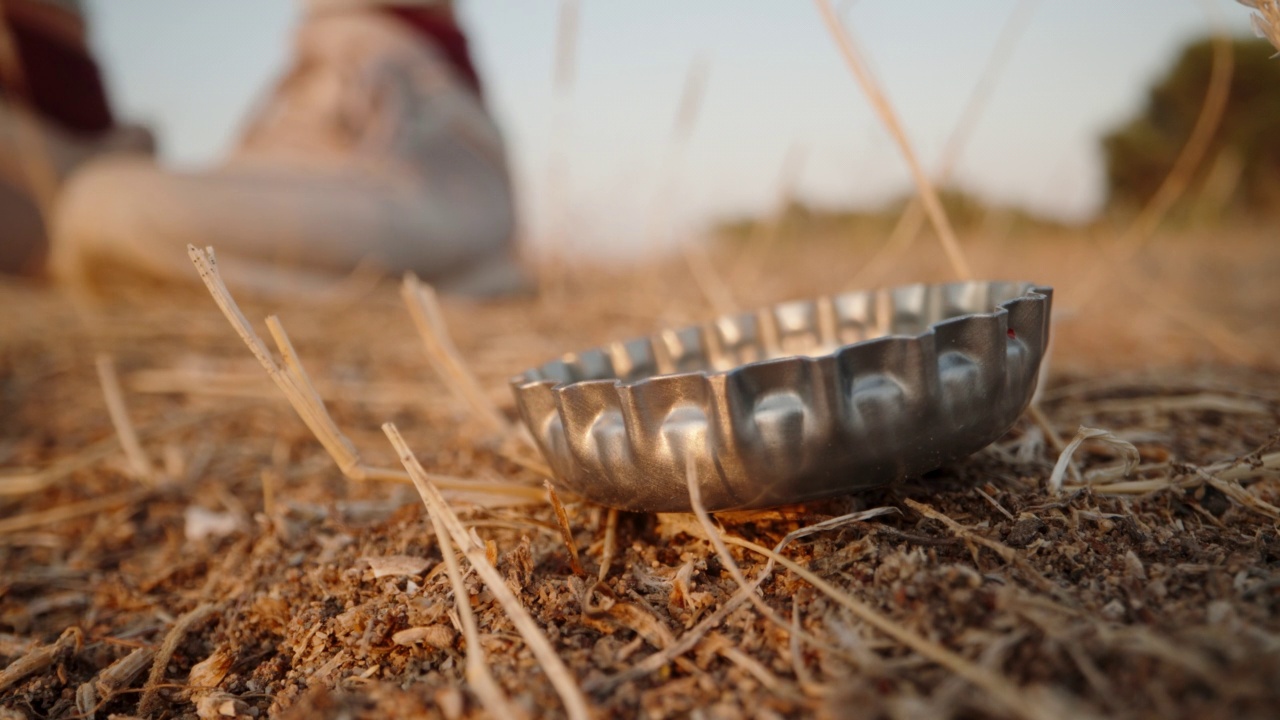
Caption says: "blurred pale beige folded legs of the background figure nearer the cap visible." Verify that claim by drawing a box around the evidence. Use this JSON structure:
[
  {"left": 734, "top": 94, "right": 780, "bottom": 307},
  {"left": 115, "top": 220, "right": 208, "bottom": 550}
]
[{"left": 54, "top": 3, "right": 527, "bottom": 295}]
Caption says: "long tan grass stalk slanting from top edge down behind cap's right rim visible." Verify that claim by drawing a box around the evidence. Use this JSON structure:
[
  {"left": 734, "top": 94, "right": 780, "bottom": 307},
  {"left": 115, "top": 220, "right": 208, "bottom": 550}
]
[{"left": 814, "top": 0, "right": 973, "bottom": 281}]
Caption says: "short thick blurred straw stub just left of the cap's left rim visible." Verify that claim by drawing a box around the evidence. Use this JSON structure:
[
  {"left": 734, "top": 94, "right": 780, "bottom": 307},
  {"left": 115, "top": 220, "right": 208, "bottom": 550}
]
[{"left": 401, "top": 273, "right": 512, "bottom": 436}]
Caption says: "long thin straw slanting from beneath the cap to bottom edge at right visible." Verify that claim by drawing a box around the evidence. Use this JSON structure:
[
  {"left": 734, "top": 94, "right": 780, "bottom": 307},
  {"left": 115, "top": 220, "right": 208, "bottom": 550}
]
[{"left": 724, "top": 536, "right": 1059, "bottom": 720}]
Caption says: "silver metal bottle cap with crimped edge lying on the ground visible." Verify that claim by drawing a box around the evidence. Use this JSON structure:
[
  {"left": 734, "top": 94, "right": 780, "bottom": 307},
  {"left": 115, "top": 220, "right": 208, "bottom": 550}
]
[{"left": 511, "top": 282, "right": 1053, "bottom": 512}]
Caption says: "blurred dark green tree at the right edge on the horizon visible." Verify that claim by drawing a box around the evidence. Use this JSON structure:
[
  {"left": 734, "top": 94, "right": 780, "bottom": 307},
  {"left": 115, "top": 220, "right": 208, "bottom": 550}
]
[{"left": 1102, "top": 38, "right": 1280, "bottom": 215}]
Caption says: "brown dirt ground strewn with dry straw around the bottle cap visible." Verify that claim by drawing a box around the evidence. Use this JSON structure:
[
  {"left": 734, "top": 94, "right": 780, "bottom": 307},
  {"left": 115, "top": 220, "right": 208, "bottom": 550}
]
[{"left": 0, "top": 229, "right": 1280, "bottom": 719}]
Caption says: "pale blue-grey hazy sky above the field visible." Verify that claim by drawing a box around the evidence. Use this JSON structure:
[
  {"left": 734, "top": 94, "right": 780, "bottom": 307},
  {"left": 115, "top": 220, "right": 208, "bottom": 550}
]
[{"left": 87, "top": 0, "right": 1248, "bottom": 254}]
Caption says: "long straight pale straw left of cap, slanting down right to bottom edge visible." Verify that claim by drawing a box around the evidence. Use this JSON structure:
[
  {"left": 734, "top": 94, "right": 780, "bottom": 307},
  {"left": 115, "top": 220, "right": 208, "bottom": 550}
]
[{"left": 383, "top": 423, "right": 590, "bottom": 720}]
